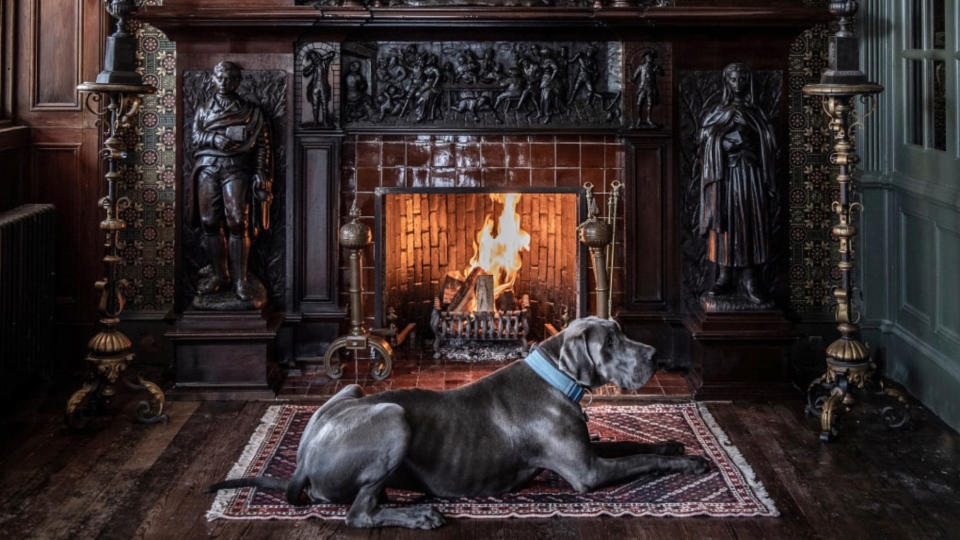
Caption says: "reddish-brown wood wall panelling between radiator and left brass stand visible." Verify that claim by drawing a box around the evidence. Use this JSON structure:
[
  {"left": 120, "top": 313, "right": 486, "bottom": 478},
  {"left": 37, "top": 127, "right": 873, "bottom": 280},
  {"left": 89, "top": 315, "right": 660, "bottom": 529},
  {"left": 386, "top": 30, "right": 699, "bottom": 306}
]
[{"left": 14, "top": 0, "right": 108, "bottom": 338}]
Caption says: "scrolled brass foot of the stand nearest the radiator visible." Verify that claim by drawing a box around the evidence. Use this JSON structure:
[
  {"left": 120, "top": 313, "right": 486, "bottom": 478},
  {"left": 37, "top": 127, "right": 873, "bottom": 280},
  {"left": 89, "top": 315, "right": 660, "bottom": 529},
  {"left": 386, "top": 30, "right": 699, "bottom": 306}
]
[{"left": 66, "top": 329, "right": 169, "bottom": 429}]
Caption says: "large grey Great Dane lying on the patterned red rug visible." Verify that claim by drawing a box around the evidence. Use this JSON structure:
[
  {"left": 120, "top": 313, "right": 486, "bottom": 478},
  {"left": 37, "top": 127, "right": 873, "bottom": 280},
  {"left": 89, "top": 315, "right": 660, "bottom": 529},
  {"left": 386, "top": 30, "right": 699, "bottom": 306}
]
[{"left": 207, "top": 317, "right": 710, "bottom": 529}]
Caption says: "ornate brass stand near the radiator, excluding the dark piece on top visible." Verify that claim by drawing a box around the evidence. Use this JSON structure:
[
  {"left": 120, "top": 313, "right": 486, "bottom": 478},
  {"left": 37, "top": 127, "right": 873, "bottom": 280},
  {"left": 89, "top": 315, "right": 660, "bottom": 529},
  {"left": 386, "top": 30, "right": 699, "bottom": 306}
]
[{"left": 67, "top": 83, "right": 167, "bottom": 427}]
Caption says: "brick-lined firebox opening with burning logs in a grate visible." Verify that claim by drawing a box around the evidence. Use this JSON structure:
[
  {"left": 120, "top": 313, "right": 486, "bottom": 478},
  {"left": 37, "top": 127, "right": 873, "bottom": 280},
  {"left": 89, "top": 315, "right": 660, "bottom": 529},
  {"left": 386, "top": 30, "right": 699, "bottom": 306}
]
[{"left": 374, "top": 187, "right": 586, "bottom": 349}]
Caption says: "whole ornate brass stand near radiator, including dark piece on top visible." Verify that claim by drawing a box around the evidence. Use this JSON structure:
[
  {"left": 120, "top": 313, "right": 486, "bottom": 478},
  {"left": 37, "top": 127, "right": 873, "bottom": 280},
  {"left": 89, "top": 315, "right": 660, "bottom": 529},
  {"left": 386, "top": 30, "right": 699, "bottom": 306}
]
[{"left": 66, "top": 0, "right": 167, "bottom": 427}]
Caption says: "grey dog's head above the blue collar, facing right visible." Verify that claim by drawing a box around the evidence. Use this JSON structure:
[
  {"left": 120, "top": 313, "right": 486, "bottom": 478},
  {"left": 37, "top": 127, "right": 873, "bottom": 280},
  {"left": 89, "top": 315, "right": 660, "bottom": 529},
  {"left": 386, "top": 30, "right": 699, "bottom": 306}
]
[{"left": 558, "top": 317, "right": 657, "bottom": 390}]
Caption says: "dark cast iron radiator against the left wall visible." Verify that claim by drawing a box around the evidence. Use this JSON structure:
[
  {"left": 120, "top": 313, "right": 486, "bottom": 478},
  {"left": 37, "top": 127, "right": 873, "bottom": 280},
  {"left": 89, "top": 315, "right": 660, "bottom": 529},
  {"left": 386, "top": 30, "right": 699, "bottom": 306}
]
[{"left": 0, "top": 204, "right": 56, "bottom": 395}]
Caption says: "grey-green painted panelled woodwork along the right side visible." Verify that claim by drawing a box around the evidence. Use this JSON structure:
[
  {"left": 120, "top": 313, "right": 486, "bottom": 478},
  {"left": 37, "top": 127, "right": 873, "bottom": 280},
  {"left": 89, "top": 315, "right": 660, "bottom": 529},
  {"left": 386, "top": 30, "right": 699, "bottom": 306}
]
[{"left": 858, "top": 0, "right": 960, "bottom": 429}]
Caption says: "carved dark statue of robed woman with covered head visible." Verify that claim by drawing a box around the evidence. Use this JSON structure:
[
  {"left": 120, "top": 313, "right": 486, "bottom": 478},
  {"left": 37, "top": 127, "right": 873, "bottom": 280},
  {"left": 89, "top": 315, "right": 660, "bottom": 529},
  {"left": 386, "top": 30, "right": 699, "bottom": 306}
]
[{"left": 699, "top": 63, "right": 776, "bottom": 305}]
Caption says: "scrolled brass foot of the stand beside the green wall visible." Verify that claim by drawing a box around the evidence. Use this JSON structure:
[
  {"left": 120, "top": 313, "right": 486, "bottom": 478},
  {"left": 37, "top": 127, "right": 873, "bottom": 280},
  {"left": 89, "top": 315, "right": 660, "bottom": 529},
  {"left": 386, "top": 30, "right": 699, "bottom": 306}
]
[{"left": 806, "top": 344, "right": 910, "bottom": 442}]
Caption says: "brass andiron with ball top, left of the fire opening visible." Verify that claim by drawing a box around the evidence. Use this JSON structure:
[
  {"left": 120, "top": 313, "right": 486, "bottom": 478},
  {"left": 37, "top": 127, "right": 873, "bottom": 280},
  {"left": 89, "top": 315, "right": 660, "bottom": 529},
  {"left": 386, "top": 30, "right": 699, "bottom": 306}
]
[{"left": 323, "top": 199, "right": 393, "bottom": 381}]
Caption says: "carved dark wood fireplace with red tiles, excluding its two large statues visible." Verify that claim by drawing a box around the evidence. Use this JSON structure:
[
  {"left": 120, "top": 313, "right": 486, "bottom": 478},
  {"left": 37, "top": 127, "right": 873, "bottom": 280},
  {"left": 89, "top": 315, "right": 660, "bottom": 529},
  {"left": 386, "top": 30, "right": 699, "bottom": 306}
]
[{"left": 150, "top": 0, "right": 825, "bottom": 395}]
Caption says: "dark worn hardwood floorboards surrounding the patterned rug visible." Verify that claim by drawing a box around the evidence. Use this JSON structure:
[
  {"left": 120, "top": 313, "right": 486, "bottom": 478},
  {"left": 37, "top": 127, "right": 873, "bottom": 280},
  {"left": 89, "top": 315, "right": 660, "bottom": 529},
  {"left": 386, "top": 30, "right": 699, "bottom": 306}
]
[{"left": 0, "top": 380, "right": 960, "bottom": 539}]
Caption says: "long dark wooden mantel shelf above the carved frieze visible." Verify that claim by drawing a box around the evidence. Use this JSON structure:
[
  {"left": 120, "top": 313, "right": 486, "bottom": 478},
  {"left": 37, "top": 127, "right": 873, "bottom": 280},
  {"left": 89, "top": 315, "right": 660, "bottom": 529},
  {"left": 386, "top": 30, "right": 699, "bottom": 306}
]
[{"left": 139, "top": 4, "right": 830, "bottom": 35}]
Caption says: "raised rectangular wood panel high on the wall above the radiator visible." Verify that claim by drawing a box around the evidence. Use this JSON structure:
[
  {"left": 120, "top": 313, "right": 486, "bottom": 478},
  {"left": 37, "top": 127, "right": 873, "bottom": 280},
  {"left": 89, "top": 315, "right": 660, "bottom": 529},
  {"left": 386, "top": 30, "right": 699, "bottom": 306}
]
[{"left": 30, "top": 0, "right": 83, "bottom": 110}]
